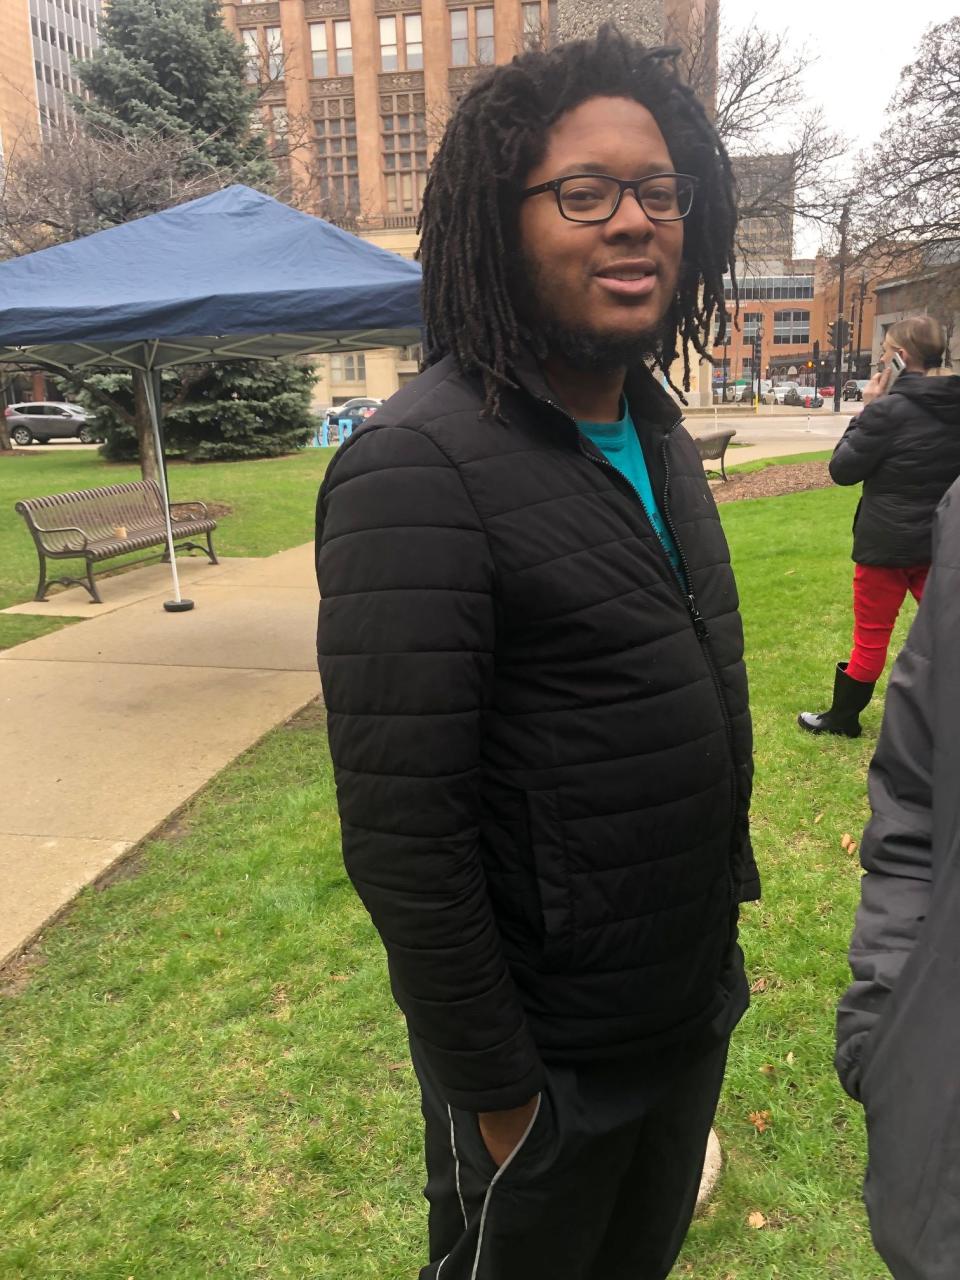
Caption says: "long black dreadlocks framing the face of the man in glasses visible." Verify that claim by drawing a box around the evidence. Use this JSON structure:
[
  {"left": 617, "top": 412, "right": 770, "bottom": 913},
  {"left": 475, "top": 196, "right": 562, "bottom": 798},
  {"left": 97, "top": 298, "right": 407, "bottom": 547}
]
[{"left": 417, "top": 26, "right": 737, "bottom": 415}]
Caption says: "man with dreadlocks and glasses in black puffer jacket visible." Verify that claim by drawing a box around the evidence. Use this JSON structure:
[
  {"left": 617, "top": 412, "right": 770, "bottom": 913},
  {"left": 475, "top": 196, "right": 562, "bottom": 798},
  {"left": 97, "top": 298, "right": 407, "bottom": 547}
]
[{"left": 317, "top": 28, "right": 758, "bottom": 1280}]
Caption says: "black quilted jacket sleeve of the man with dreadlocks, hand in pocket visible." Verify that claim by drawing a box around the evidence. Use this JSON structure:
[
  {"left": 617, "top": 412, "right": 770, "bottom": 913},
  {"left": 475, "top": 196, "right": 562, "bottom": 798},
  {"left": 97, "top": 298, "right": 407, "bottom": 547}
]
[{"left": 316, "top": 426, "right": 543, "bottom": 1111}]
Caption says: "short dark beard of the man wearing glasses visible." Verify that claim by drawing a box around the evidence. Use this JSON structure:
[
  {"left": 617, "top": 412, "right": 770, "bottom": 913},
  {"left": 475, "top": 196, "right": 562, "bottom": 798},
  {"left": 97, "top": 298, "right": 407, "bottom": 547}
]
[{"left": 515, "top": 248, "right": 663, "bottom": 374}]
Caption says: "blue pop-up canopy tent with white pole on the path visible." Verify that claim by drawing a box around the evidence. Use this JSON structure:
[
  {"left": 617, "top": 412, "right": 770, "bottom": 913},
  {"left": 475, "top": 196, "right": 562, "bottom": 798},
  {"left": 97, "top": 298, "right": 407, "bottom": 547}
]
[{"left": 0, "top": 186, "right": 421, "bottom": 611}]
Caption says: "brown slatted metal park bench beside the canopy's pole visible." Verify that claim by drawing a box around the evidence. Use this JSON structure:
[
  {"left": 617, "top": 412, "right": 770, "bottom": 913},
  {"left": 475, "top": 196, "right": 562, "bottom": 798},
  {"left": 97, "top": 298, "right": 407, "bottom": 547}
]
[{"left": 15, "top": 480, "right": 218, "bottom": 604}]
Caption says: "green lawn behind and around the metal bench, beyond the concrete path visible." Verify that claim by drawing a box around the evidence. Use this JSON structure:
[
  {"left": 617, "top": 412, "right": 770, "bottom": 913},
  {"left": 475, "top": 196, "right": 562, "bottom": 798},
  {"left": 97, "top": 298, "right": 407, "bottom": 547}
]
[{"left": 0, "top": 445, "right": 335, "bottom": 649}]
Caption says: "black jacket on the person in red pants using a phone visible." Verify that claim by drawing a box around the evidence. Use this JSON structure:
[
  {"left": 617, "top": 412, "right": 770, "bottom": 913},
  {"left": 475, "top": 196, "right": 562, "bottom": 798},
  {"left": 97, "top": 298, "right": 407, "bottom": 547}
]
[{"left": 829, "top": 374, "right": 960, "bottom": 568}]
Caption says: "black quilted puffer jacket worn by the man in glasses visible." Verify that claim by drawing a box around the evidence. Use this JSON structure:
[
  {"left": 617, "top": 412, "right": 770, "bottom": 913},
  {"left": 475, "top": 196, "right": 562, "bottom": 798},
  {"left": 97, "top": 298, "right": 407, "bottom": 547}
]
[{"left": 317, "top": 360, "right": 758, "bottom": 1110}]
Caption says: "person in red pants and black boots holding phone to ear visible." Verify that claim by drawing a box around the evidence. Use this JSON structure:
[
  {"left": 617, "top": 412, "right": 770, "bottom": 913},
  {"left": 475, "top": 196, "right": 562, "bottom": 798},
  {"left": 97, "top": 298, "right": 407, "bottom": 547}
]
[{"left": 799, "top": 315, "right": 960, "bottom": 737}]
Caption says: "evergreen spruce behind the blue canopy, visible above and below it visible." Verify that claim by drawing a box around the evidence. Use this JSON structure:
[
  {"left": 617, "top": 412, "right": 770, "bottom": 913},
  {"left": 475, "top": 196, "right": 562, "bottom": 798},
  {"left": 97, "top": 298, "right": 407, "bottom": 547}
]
[{"left": 76, "top": 0, "right": 315, "bottom": 475}]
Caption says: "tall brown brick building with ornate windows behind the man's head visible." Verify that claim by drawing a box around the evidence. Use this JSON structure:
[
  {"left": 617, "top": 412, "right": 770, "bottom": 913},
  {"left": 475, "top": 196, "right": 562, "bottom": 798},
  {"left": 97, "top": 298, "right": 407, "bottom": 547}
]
[{"left": 223, "top": 0, "right": 717, "bottom": 403}]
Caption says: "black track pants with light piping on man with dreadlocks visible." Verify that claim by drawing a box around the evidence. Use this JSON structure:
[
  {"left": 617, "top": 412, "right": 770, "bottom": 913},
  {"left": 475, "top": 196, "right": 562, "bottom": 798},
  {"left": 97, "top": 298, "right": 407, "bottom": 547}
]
[{"left": 411, "top": 1041, "right": 727, "bottom": 1280}]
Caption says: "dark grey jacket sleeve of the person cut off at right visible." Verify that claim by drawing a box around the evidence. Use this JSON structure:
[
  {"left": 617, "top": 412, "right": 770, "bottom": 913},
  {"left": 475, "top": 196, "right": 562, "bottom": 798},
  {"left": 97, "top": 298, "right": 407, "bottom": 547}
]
[{"left": 836, "top": 519, "right": 942, "bottom": 1100}]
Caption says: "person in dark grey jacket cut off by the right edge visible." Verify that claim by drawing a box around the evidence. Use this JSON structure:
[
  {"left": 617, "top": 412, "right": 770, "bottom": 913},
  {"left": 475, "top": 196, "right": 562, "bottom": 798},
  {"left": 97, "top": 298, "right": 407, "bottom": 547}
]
[{"left": 837, "top": 481, "right": 960, "bottom": 1280}]
